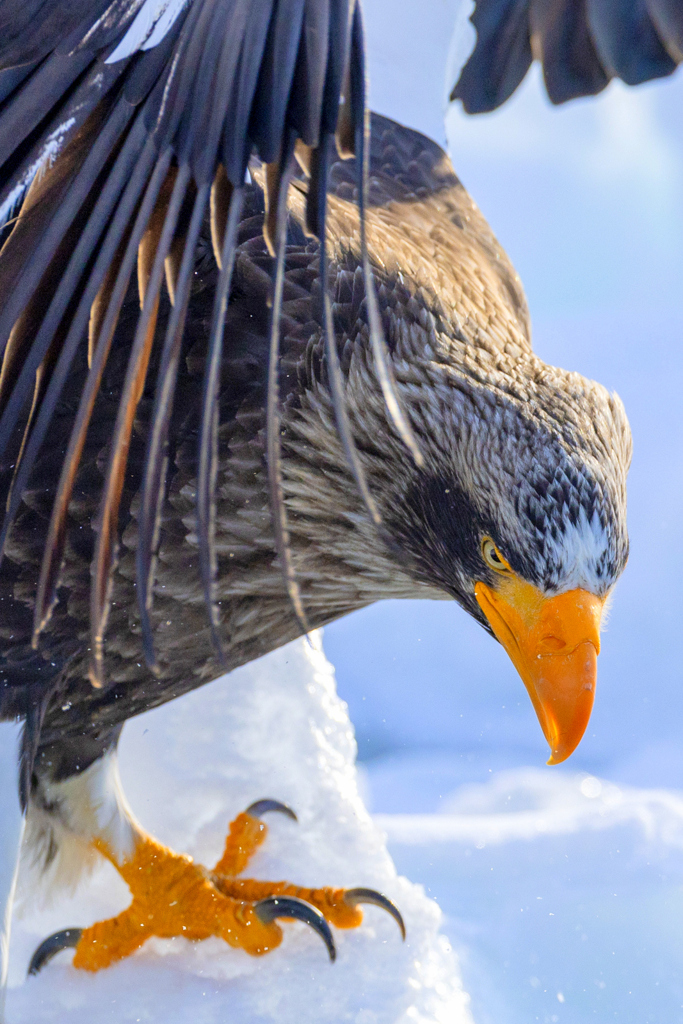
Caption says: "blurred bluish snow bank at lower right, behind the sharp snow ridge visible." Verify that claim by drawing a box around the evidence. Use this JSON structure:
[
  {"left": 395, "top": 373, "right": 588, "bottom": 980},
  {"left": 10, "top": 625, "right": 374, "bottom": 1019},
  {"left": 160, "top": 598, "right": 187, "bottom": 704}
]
[{"left": 378, "top": 758, "right": 683, "bottom": 1024}]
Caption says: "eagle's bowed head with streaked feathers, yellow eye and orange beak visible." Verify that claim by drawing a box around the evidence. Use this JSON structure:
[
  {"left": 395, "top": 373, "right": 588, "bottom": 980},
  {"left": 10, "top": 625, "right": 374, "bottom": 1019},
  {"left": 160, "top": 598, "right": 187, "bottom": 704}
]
[{"left": 370, "top": 353, "right": 631, "bottom": 764}]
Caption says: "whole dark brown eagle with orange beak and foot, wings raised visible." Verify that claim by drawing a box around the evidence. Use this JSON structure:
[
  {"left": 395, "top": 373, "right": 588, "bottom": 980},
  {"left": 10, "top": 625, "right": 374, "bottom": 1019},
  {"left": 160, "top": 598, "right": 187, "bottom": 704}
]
[{"left": 0, "top": 0, "right": 678, "bottom": 995}]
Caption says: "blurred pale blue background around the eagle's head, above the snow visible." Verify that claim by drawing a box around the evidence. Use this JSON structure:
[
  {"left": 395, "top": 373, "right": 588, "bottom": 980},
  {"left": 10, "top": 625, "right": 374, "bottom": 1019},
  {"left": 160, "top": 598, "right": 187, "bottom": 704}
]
[{"left": 325, "top": 0, "right": 683, "bottom": 812}]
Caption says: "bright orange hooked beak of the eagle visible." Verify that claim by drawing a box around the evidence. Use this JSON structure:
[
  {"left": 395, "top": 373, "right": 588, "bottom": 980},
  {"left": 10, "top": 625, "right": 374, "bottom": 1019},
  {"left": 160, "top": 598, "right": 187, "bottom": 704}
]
[{"left": 474, "top": 577, "right": 604, "bottom": 765}]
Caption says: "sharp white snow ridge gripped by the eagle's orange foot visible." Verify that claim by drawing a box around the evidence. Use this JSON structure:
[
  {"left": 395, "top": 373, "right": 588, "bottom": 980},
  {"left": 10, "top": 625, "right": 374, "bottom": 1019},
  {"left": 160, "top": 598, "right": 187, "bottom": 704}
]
[{"left": 7, "top": 637, "right": 471, "bottom": 1024}]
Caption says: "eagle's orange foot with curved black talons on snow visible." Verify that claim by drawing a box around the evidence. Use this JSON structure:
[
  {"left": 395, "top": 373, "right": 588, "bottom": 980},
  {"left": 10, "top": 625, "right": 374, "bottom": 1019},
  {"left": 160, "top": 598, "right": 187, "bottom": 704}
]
[{"left": 30, "top": 801, "right": 405, "bottom": 974}]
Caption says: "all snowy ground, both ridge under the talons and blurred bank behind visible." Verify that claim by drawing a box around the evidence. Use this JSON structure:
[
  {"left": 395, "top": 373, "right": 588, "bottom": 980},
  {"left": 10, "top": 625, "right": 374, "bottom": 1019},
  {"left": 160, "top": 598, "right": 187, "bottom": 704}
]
[{"left": 7, "top": 641, "right": 683, "bottom": 1024}]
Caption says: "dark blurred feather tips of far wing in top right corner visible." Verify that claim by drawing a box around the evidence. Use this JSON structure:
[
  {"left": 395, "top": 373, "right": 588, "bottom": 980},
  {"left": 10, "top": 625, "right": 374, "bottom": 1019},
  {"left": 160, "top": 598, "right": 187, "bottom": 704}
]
[{"left": 451, "top": 0, "right": 683, "bottom": 114}]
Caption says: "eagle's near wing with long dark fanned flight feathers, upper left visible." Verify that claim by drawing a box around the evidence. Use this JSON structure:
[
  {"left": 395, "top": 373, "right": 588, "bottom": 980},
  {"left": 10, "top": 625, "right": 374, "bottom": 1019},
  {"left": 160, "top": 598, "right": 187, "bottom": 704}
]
[{"left": 0, "top": 0, "right": 421, "bottom": 685}]
